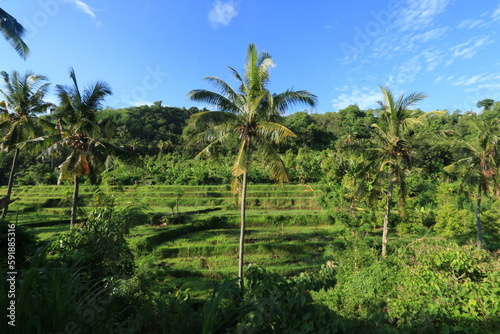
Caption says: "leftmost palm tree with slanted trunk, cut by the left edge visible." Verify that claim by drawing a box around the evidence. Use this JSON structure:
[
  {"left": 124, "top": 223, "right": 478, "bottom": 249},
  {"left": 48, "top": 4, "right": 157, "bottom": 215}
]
[{"left": 0, "top": 71, "right": 53, "bottom": 218}]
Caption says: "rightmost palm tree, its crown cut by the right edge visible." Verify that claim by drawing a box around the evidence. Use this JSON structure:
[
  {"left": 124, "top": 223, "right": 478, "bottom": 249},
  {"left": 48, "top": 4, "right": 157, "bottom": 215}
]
[{"left": 445, "top": 116, "right": 500, "bottom": 249}]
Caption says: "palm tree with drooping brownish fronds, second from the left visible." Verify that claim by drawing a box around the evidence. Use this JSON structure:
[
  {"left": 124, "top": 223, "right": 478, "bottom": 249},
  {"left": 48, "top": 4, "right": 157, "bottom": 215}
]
[{"left": 54, "top": 69, "right": 117, "bottom": 228}]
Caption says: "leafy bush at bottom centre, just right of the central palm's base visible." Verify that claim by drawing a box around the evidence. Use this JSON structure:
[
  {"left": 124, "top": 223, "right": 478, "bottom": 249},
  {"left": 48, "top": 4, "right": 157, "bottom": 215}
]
[{"left": 237, "top": 266, "right": 337, "bottom": 333}]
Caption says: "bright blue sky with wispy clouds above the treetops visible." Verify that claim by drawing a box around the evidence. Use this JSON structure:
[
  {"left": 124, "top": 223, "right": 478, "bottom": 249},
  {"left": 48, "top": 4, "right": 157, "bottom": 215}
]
[{"left": 0, "top": 0, "right": 500, "bottom": 113}]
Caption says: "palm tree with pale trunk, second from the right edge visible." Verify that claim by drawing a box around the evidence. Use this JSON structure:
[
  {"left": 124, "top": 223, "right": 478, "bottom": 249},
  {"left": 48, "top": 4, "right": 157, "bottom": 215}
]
[{"left": 367, "top": 87, "right": 426, "bottom": 257}]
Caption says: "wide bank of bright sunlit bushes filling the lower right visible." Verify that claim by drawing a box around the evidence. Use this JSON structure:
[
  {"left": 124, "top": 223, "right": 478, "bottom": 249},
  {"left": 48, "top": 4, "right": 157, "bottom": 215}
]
[{"left": 317, "top": 239, "right": 500, "bottom": 333}]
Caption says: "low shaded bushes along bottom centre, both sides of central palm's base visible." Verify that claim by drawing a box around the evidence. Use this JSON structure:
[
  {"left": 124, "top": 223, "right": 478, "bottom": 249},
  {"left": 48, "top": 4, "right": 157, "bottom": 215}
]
[{"left": 157, "top": 266, "right": 337, "bottom": 334}]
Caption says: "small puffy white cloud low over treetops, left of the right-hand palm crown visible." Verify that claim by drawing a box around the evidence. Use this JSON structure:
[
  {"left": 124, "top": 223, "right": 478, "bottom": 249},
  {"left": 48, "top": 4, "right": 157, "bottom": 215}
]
[{"left": 332, "top": 86, "right": 382, "bottom": 110}]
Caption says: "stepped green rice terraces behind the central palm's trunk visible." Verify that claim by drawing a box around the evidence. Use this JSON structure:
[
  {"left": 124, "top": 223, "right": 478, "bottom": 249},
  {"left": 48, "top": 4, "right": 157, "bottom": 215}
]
[{"left": 0, "top": 185, "right": 335, "bottom": 294}]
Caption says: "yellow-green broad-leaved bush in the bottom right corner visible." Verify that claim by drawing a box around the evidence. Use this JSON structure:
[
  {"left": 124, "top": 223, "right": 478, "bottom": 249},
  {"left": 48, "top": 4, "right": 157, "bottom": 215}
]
[{"left": 387, "top": 241, "right": 500, "bottom": 333}]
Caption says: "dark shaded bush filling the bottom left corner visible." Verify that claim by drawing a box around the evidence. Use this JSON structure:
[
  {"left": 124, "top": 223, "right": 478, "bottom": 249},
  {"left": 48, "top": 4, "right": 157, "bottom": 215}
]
[{"left": 0, "top": 245, "right": 126, "bottom": 334}]
